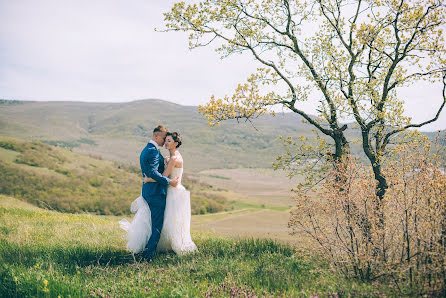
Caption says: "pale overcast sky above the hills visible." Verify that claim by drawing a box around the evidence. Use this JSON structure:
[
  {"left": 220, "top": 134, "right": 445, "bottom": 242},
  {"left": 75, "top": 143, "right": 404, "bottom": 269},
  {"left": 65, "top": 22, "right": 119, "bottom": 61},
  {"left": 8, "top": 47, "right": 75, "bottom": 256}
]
[{"left": 0, "top": 0, "right": 446, "bottom": 130}]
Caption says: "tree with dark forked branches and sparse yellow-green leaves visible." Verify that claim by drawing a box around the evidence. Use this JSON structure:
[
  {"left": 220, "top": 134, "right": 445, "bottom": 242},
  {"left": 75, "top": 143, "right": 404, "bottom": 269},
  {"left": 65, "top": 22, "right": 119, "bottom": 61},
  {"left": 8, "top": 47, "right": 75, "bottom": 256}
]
[{"left": 165, "top": 0, "right": 446, "bottom": 200}]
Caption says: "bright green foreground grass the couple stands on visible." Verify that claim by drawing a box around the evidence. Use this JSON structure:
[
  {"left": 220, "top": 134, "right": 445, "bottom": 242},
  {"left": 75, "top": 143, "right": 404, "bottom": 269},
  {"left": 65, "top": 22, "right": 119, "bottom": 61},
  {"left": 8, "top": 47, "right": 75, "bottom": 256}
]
[{"left": 0, "top": 195, "right": 395, "bottom": 297}]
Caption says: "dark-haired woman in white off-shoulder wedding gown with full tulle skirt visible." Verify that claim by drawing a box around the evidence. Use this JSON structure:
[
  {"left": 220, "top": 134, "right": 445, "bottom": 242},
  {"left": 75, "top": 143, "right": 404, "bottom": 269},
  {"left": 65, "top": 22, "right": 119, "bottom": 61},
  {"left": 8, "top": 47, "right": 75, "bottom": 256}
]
[{"left": 119, "top": 132, "right": 197, "bottom": 255}]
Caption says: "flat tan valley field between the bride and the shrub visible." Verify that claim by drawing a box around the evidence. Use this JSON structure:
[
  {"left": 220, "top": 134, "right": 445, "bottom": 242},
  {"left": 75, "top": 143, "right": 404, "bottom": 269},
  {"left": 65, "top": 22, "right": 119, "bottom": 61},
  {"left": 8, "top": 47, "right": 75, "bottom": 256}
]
[{"left": 192, "top": 168, "right": 301, "bottom": 244}]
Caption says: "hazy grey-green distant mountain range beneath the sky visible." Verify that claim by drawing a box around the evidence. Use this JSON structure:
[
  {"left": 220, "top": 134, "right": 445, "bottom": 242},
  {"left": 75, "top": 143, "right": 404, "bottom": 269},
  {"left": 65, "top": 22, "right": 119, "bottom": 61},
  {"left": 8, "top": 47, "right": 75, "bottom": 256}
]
[{"left": 0, "top": 99, "right": 440, "bottom": 172}]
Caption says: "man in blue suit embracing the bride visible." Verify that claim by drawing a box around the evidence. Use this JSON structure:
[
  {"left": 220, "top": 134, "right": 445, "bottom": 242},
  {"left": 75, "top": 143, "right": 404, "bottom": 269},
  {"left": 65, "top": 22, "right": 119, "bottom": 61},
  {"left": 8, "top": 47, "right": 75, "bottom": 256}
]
[{"left": 139, "top": 125, "right": 178, "bottom": 260}]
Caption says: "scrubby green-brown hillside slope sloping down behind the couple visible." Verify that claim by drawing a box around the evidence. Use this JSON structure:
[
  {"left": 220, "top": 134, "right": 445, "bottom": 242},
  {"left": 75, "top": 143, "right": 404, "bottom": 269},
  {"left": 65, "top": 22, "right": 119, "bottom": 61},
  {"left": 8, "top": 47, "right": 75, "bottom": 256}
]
[{"left": 0, "top": 136, "right": 232, "bottom": 215}]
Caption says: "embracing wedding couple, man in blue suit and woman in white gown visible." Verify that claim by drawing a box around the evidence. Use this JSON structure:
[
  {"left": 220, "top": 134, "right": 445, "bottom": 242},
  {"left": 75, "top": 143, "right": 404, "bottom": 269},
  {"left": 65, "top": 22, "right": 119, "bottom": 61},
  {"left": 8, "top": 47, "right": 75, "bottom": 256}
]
[{"left": 119, "top": 125, "right": 197, "bottom": 260}]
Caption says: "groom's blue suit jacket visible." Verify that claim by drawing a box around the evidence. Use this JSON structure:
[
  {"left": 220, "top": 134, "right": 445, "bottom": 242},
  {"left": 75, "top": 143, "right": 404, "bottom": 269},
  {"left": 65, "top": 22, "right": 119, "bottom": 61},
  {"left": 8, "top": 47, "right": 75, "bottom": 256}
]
[{"left": 139, "top": 143, "right": 170, "bottom": 203}]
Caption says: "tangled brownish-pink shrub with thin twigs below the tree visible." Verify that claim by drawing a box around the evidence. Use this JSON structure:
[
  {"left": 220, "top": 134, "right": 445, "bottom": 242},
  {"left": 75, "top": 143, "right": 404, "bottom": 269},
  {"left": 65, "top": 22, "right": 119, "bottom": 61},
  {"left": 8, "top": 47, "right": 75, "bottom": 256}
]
[{"left": 289, "top": 138, "right": 446, "bottom": 295}]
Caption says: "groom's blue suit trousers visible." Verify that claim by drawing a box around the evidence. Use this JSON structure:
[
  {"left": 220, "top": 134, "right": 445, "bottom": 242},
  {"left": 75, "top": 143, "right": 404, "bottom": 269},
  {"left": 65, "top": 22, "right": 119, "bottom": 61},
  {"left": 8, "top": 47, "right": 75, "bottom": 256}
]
[{"left": 143, "top": 195, "right": 166, "bottom": 259}]
